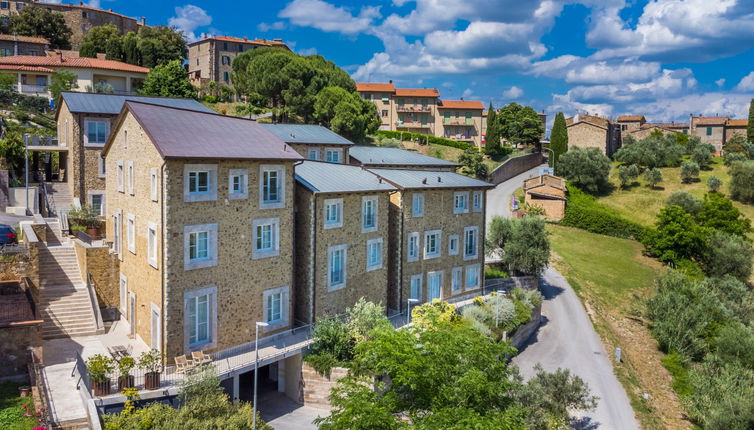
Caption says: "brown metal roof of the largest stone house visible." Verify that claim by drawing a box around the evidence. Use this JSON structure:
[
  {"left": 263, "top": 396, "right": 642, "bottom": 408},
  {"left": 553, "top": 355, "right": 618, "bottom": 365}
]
[{"left": 110, "top": 101, "right": 303, "bottom": 160}]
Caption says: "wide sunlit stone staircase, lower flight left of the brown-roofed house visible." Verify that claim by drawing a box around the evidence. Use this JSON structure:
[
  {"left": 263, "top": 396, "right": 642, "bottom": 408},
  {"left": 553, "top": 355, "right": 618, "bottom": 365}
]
[{"left": 39, "top": 244, "right": 98, "bottom": 339}]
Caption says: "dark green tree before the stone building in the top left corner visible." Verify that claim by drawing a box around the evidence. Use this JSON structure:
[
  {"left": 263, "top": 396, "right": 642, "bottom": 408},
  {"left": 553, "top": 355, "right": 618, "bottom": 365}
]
[{"left": 8, "top": 4, "right": 71, "bottom": 49}]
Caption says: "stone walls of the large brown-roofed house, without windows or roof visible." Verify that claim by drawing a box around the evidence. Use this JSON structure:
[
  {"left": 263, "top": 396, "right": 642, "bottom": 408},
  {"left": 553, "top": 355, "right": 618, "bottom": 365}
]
[{"left": 106, "top": 113, "right": 294, "bottom": 358}]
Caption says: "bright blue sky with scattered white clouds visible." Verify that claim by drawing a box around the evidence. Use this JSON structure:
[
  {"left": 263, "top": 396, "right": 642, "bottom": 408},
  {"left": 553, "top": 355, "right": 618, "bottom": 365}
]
[{"left": 79, "top": 0, "right": 754, "bottom": 126}]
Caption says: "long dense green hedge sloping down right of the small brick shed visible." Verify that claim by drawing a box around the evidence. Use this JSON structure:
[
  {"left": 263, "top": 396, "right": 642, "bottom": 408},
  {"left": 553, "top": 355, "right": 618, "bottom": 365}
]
[{"left": 560, "top": 185, "right": 649, "bottom": 242}]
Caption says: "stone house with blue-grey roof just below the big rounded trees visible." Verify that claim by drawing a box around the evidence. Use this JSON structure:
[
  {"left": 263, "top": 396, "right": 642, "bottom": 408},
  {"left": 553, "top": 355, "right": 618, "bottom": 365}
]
[{"left": 261, "top": 124, "right": 353, "bottom": 164}]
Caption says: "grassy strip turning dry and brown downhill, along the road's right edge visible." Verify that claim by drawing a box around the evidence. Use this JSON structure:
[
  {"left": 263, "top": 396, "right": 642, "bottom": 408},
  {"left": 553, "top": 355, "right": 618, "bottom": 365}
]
[{"left": 548, "top": 225, "right": 690, "bottom": 429}]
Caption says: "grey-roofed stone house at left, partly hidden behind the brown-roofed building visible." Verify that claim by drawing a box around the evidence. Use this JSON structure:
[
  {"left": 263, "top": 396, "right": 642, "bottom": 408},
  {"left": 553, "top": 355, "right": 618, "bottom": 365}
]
[{"left": 55, "top": 92, "right": 212, "bottom": 210}]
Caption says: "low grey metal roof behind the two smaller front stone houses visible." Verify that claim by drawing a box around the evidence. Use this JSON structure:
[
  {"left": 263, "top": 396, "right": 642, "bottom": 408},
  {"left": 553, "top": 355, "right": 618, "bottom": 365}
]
[{"left": 350, "top": 146, "right": 461, "bottom": 172}]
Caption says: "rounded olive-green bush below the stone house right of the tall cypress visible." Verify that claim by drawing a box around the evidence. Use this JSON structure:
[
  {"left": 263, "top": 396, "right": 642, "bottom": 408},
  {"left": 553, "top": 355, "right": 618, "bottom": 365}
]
[{"left": 556, "top": 148, "right": 610, "bottom": 193}]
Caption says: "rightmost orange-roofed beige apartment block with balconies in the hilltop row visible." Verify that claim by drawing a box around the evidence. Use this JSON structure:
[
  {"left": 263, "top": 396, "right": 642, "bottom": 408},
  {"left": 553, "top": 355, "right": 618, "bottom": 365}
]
[{"left": 436, "top": 100, "right": 485, "bottom": 148}]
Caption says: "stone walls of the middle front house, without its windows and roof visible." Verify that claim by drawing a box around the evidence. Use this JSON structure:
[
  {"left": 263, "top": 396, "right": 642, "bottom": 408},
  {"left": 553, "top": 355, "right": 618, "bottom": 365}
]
[{"left": 295, "top": 185, "right": 389, "bottom": 323}]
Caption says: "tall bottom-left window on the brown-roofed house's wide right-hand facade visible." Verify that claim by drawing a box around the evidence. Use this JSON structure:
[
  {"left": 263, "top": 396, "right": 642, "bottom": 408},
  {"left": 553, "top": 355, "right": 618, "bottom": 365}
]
[{"left": 184, "top": 286, "right": 217, "bottom": 348}]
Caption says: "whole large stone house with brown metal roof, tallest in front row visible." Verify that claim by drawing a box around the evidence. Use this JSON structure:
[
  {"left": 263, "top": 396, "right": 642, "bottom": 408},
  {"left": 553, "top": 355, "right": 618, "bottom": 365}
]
[{"left": 103, "top": 101, "right": 302, "bottom": 361}]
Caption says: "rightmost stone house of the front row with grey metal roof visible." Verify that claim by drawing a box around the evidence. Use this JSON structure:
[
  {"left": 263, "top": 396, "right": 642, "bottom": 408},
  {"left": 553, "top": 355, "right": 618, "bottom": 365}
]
[{"left": 369, "top": 169, "right": 492, "bottom": 312}]
